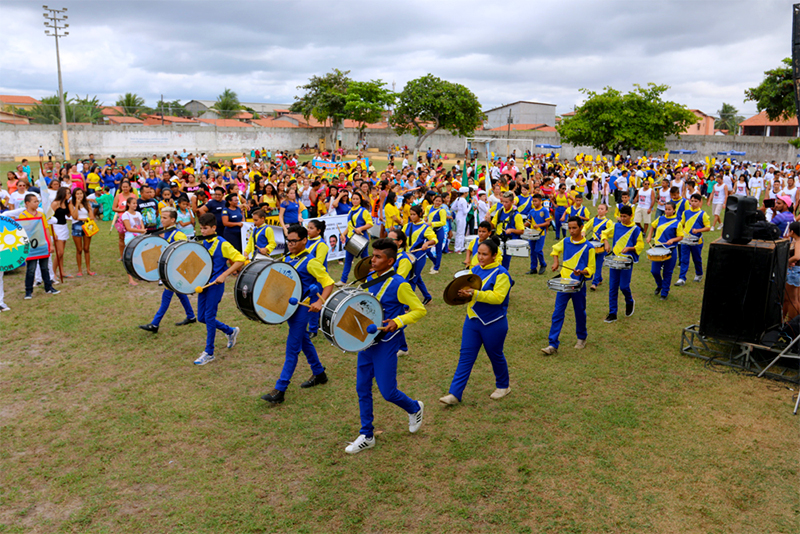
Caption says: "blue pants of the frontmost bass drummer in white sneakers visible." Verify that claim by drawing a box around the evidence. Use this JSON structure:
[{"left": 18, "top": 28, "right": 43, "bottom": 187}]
[{"left": 356, "top": 334, "right": 419, "bottom": 438}]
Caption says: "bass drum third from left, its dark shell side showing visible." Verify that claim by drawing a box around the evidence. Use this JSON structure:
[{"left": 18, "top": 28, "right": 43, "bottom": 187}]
[{"left": 233, "top": 259, "right": 303, "bottom": 324}]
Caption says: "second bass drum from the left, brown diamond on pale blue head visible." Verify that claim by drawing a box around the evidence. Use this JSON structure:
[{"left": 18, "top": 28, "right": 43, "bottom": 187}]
[{"left": 159, "top": 241, "right": 213, "bottom": 295}]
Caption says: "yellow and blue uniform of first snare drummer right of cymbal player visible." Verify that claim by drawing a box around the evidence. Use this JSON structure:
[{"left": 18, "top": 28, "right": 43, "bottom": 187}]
[{"left": 548, "top": 237, "right": 595, "bottom": 349}]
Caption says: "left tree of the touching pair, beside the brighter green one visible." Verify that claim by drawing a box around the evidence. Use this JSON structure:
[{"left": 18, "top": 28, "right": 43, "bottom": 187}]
[{"left": 289, "top": 69, "right": 352, "bottom": 147}]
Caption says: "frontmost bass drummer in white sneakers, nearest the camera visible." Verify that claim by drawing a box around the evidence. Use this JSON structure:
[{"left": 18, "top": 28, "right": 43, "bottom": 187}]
[{"left": 345, "top": 239, "right": 427, "bottom": 454}]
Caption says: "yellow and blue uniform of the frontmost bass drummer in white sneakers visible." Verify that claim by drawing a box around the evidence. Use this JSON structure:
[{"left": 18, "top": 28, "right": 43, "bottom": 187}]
[{"left": 356, "top": 273, "right": 428, "bottom": 438}]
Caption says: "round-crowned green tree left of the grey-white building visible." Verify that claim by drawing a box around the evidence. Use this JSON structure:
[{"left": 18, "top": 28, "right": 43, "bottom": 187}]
[{"left": 390, "top": 74, "right": 485, "bottom": 159}]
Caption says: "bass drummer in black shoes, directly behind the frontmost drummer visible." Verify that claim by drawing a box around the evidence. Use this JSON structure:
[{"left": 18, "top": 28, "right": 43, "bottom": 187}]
[{"left": 261, "top": 224, "right": 333, "bottom": 404}]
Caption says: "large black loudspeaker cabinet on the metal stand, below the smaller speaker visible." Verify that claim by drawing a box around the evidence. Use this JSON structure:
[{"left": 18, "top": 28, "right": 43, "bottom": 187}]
[{"left": 700, "top": 239, "right": 789, "bottom": 343}]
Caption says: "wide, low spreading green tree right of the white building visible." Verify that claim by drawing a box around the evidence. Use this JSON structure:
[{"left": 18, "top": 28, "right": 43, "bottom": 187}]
[{"left": 556, "top": 83, "right": 698, "bottom": 155}]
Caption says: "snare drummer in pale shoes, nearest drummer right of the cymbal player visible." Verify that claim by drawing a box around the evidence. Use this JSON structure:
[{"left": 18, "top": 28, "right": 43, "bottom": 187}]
[{"left": 542, "top": 216, "right": 596, "bottom": 356}]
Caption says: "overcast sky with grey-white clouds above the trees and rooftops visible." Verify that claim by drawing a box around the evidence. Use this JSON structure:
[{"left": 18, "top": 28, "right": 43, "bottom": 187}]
[{"left": 0, "top": 0, "right": 797, "bottom": 116}]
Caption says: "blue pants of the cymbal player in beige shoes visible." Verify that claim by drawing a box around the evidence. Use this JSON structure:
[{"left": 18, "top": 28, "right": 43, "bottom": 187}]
[{"left": 449, "top": 317, "right": 508, "bottom": 400}]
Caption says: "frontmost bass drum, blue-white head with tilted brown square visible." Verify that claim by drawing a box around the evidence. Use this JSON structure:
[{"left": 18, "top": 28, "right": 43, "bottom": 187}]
[{"left": 319, "top": 287, "right": 383, "bottom": 352}]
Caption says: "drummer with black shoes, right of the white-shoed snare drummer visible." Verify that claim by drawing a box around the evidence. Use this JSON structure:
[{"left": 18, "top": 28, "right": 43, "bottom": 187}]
[{"left": 602, "top": 206, "right": 644, "bottom": 323}]
